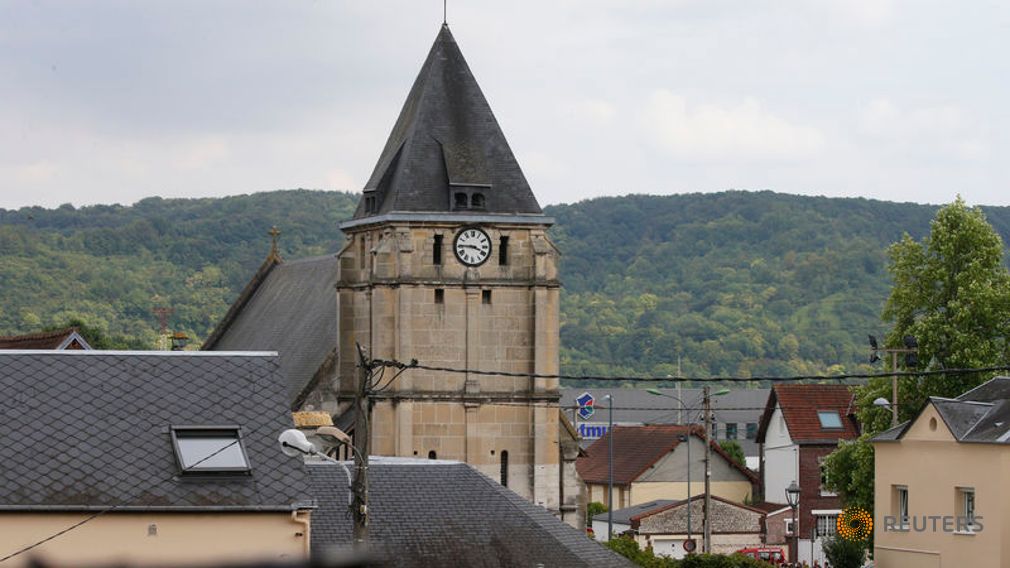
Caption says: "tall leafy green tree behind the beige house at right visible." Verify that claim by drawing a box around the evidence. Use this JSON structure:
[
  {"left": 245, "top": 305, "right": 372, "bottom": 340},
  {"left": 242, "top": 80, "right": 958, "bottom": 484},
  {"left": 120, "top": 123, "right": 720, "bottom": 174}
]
[{"left": 825, "top": 197, "right": 1010, "bottom": 511}]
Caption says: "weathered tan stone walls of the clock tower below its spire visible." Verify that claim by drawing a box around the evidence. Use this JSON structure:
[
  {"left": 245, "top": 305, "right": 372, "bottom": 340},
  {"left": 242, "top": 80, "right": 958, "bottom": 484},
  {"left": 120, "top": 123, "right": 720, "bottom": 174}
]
[{"left": 331, "top": 222, "right": 569, "bottom": 510}]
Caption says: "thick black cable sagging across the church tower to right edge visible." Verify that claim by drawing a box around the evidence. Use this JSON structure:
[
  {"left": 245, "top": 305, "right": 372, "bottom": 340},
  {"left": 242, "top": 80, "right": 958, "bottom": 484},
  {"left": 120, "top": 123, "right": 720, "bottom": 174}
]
[{"left": 372, "top": 359, "right": 1010, "bottom": 383}]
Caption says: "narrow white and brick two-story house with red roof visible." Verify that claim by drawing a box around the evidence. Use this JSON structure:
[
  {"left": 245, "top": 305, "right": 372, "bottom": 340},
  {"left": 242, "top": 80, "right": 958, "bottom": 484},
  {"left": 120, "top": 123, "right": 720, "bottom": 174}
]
[{"left": 758, "top": 384, "right": 859, "bottom": 564}]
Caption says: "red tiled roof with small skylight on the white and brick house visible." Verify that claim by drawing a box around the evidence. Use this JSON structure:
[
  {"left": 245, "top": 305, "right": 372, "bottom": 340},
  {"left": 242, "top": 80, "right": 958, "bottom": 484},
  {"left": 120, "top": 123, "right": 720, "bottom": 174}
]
[{"left": 758, "top": 384, "right": 860, "bottom": 444}]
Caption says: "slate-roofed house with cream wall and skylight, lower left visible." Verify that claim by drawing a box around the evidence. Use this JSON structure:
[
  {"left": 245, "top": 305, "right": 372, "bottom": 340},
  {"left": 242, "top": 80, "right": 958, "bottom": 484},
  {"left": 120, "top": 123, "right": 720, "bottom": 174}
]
[{"left": 0, "top": 351, "right": 314, "bottom": 567}]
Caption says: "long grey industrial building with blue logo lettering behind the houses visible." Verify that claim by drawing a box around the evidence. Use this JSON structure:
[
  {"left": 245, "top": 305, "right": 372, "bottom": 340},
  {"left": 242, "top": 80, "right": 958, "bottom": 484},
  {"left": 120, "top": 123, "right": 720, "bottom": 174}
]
[{"left": 560, "top": 388, "right": 770, "bottom": 457}]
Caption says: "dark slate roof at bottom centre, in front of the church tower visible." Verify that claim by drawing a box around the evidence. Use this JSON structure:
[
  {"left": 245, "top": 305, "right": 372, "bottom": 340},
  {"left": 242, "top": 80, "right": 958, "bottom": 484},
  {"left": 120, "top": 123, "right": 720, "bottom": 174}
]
[{"left": 307, "top": 457, "right": 632, "bottom": 568}]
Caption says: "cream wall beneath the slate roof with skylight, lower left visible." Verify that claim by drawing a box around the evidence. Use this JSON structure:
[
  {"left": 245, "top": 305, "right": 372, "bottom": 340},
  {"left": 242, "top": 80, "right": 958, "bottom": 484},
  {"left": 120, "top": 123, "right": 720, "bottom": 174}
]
[{"left": 0, "top": 512, "right": 309, "bottom": 568}]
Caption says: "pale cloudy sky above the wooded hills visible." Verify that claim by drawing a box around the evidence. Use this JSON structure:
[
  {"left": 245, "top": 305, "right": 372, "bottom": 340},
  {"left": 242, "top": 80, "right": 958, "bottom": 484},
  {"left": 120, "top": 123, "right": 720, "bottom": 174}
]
[{"left": 0, "top": 0, "right": 1010, "bottom": 208}]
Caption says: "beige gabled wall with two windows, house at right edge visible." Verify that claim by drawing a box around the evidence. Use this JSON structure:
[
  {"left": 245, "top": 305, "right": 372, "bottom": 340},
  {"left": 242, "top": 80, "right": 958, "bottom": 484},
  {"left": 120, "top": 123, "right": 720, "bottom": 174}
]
[{"left": 874, "top": 406, "right": 1010, "bottom": 568}]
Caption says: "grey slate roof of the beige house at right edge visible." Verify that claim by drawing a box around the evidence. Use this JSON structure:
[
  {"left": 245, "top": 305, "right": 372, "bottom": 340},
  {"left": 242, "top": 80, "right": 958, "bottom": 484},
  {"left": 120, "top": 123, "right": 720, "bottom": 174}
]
[{"left": 873, "top": 377, "right": 1010, "bottom": 444}]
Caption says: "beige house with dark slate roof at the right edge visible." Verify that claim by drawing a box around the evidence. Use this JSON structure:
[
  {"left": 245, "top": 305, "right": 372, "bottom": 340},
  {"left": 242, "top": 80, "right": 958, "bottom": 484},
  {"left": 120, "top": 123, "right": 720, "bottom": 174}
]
[{"left": 873, "top": 377, "right": 1010, "bottom": 568}]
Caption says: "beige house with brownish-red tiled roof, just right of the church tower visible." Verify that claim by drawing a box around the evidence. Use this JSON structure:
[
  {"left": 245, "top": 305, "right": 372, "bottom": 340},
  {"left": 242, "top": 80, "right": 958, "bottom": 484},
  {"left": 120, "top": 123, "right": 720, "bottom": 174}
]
[{"left": 577, "top": 424, "right": 758, "bottom": 508}]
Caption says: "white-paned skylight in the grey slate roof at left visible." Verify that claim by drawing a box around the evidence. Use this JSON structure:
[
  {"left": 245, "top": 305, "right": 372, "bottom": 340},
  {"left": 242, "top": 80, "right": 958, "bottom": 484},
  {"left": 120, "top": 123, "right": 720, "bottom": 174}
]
[{"left": 172, "top": 427, "right": 250, "bottom": 474}]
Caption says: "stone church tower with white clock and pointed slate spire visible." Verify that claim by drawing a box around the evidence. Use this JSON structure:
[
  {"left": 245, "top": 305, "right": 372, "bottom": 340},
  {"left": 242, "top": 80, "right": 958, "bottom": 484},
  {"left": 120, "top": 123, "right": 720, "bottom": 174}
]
[{"left": 336, "top": 25, "right": 561, "bottom": 511}]
